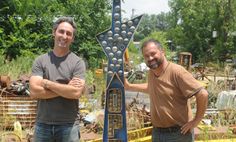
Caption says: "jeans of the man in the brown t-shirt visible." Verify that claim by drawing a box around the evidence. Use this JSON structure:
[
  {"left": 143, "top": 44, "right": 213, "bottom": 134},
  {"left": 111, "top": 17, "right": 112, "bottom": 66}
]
[{"left": 152, "top": 127, "right": 194, "bottom": 142}]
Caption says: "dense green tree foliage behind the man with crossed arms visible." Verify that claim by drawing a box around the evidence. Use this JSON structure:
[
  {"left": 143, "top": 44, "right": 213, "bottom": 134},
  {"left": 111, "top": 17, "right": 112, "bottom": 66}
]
[{"left": 0, "top": 0, "right": 111, "bottom": 67}]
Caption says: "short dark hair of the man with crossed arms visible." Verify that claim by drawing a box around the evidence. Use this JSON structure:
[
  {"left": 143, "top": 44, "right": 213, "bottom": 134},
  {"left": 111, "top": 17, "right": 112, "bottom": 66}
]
[{"left": 53, "top": 16, "right": 77, "bottom": 36}]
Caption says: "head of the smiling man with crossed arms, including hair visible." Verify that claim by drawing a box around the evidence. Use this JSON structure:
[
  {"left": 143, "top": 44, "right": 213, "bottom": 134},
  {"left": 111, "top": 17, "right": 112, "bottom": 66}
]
[{"left": 53, "top": 17, "right": 76, "bottom": 48}]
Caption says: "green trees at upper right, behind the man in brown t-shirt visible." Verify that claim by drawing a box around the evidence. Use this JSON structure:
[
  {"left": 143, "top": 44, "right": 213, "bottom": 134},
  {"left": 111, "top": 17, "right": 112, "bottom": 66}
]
[{"left": 167, "top": 0, "right": 236, "bottom": 62}]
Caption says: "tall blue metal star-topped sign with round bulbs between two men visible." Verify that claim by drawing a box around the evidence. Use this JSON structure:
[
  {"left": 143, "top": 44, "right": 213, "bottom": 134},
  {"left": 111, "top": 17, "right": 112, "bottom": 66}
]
[{"left": 97, "top": 0, "right": 142, "bottom": 142}]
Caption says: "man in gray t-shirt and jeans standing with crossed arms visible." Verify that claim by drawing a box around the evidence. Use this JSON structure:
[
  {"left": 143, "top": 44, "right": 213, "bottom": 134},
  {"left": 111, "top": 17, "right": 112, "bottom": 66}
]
[{"left": 30, "top": 17, "right": 85, "bottom": 142}]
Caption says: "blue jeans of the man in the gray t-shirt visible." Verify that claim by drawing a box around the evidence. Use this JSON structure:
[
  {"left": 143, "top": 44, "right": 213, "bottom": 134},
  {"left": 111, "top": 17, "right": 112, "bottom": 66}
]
[{"left": 33, "top": 123, "right": 80, "bottom": 142}]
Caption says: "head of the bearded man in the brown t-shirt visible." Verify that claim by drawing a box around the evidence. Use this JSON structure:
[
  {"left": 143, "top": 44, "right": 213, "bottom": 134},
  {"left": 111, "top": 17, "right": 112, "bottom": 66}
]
[{"left": 141, "top": 39, "right": 165, "bottom": 69}]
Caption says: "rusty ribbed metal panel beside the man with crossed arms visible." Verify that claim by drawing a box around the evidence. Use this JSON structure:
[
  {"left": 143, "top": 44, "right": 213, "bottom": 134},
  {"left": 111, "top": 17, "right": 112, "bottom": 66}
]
[{"left": 0, "top": 94, "right": 37, "bottom": 129}]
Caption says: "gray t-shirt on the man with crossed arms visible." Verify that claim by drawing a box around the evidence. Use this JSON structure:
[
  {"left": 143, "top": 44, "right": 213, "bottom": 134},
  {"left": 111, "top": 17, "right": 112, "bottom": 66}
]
[{"left": 32, "top": 51, "right": 86, "bottom": 124}]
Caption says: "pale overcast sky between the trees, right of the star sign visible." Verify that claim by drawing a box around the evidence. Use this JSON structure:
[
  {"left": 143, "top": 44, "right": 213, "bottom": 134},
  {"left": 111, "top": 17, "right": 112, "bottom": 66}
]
[{"left": 121, "top": 0, "right": 170, "bottom": 18}]
